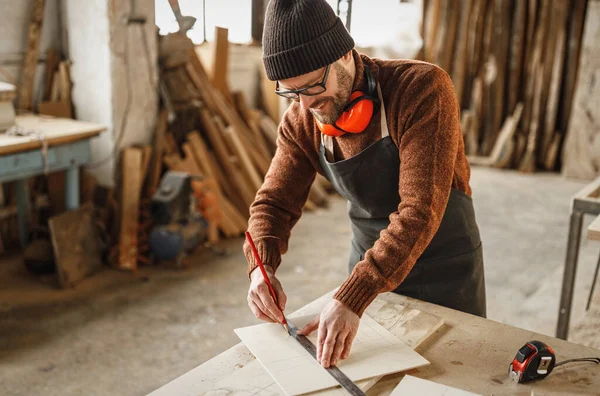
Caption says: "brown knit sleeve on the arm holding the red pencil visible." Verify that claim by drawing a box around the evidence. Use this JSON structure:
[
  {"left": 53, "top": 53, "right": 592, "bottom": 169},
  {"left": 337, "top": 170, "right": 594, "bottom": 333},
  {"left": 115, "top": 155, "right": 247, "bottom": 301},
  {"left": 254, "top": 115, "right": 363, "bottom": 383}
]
[{"left": 243, "top": 111, "right": 316, "bottom": 276}]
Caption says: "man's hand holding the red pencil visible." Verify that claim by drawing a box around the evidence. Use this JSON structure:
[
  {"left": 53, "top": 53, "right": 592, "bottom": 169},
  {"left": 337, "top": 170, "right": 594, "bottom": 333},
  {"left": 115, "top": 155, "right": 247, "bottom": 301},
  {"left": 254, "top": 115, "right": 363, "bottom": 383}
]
[{"left": 248, "top": 265, "right": 287, "bottom": 323}]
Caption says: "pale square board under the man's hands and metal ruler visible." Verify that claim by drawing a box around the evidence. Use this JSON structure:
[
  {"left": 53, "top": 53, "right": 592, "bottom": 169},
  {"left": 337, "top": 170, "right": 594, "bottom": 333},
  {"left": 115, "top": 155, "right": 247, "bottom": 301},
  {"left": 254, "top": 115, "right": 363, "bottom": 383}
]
[{"left": 235, "top": 315, "right": 429, "bottom": 395}]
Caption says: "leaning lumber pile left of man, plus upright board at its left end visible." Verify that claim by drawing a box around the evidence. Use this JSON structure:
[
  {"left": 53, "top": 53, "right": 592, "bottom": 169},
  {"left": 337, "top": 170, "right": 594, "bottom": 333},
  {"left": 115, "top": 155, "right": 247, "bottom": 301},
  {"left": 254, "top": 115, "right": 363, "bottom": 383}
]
[{"left": 105, "top": 28, "right": 330, "bottom": 270}]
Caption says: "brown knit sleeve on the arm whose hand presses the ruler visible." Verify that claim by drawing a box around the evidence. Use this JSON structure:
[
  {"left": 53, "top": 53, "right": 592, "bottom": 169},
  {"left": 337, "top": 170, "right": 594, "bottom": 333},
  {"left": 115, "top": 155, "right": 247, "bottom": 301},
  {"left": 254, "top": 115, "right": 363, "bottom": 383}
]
[{"left": 334, "top": 67, "right": 462, "bottom": 315}]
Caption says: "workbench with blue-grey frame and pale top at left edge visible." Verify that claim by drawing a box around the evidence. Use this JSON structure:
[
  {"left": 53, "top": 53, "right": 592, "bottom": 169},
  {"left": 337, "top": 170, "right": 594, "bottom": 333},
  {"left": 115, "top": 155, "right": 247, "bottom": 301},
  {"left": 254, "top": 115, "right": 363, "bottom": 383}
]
[{"left": 0, "top": 114, "right": 106, "bottom": 247}]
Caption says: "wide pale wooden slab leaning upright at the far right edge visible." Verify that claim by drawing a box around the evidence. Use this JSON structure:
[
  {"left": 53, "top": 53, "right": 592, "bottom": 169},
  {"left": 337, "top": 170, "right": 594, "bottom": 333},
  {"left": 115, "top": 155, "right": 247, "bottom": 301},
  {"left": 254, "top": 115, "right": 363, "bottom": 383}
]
[{"left": 563, "top": 1, "right": 600, "bottom": 179}]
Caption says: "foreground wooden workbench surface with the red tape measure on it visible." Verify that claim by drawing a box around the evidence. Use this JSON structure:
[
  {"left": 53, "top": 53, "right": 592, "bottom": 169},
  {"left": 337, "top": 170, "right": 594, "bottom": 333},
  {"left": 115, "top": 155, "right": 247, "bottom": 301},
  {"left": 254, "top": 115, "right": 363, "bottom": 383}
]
[{"left": 150, "top": 291, "right": 600, "bottom": 396}]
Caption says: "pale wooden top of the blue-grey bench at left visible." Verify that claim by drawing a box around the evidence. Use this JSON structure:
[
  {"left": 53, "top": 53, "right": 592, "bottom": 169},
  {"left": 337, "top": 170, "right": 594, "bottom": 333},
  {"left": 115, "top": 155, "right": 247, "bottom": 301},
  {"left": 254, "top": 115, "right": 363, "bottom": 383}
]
[{"left": 0, "top": 114, "right": 106, "bottom": 155}]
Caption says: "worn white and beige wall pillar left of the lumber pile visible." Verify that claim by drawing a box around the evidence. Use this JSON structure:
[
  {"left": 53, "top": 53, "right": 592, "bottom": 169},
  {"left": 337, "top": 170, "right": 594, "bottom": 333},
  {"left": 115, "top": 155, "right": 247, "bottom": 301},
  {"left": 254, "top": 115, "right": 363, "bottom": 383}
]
[{"left": 63, "top": 0, "right": 158, "bottom": 187}]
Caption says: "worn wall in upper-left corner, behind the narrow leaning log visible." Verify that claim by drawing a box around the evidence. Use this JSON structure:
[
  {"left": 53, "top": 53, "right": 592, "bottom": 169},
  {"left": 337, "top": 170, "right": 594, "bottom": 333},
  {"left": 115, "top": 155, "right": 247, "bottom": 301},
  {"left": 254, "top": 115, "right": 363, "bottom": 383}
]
[{"left": 0, "top": 0, "right": 61, "bottom": 103}]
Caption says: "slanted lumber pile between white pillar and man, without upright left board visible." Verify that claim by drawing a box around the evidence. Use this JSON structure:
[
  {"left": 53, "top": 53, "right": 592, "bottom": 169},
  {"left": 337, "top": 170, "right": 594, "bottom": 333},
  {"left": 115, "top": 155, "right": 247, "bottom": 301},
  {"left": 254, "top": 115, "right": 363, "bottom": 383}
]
[{"left": 155, "top": 28, "right": 329, "bottom": 241}]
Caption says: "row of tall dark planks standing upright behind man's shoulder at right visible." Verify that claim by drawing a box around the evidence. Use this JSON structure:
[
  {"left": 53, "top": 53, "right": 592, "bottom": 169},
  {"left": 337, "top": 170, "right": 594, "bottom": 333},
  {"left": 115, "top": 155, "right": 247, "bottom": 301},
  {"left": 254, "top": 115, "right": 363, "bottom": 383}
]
[{"left": 422, "top": 0, "right": 587, "bottom": 172}]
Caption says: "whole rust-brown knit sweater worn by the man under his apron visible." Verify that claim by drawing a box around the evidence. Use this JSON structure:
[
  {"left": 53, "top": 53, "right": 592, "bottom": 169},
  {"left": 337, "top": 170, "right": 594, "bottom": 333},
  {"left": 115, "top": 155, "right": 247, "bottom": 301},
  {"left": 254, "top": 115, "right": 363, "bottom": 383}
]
[{"left": 244, "top": 50, "right": 471, "bottom": 316}]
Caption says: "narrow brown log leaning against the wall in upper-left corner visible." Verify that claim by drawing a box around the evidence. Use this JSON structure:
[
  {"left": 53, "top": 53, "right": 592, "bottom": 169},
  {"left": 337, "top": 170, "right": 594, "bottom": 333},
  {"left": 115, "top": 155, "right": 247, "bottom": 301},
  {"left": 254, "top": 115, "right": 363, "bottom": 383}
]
[{"left": 19, "top": 0, "right": 45, "bottom": 111}]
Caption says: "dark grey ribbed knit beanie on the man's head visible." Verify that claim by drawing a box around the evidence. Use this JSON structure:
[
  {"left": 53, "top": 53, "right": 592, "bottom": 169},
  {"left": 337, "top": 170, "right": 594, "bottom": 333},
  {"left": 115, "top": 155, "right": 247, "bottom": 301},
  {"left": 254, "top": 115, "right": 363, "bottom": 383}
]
[{"left": 263, "top": 0, "right": 354, "bottom": 81}]
